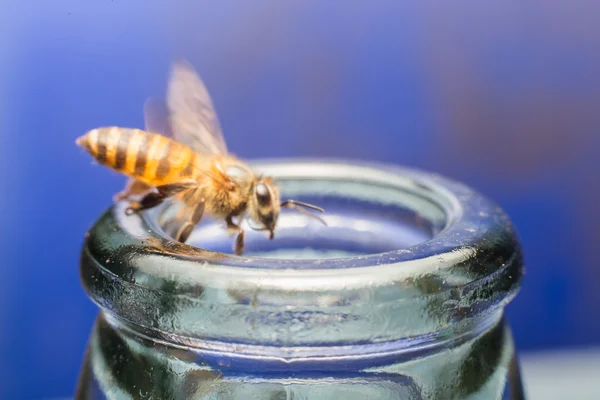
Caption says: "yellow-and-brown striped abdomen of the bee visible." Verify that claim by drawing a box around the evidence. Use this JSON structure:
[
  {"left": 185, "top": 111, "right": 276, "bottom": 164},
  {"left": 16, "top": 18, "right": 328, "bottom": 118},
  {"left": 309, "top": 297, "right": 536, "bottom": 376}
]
[{"left": 77, "top": 127, "right": 194, "bottom": 186}]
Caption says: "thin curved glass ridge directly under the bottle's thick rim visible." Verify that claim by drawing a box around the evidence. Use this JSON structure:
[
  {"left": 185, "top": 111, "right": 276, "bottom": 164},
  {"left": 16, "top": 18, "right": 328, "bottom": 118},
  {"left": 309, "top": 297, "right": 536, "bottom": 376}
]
[{"left": 102, "top": 310, "right": 503, "bottom": 371}]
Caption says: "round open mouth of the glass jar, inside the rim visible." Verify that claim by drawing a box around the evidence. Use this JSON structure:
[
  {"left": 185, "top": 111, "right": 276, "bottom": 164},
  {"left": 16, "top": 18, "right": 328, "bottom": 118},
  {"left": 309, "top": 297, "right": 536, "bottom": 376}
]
[{"left": 143, "top": 160, "right": 462, "bottom": 269}]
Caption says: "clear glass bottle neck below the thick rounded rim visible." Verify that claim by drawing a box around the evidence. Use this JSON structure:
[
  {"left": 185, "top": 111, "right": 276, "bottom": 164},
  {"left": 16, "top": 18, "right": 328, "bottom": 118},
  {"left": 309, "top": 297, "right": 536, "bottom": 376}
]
[{"left": 80, "top": 313, "right": 514, "bottom": 400}]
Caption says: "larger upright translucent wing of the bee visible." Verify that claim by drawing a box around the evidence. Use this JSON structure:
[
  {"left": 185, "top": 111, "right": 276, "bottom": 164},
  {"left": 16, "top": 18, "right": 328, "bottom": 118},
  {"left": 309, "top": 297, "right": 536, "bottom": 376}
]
[{"left": 167, "top": 60, "right": 227, "bottom": 154}]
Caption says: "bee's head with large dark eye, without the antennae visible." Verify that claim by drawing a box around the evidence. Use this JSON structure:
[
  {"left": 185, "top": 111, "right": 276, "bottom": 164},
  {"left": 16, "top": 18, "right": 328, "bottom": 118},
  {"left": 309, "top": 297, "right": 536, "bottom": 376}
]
[{"left": 249, "top": 177, "right": 280, "bottom": 239}]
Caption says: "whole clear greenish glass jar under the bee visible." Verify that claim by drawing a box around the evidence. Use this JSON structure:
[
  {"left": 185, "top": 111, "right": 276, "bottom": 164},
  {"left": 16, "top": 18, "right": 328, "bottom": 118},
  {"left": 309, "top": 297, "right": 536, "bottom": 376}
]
[{"left": 77, "top": 160, "right": 523, "bottom": 400}]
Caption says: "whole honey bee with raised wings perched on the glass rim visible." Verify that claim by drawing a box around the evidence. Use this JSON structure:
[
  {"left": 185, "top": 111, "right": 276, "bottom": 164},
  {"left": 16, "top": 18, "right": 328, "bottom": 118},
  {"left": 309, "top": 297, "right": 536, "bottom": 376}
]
[{"left": 76, "top": 60, "right": 325, "bottom": 255}]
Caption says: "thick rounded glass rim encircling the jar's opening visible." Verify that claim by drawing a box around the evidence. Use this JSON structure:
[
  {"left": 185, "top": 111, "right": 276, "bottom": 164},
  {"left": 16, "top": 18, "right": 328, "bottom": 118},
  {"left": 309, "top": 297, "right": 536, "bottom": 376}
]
[{"left": 81, "top": 159, "right": 522, "bottom": 343}]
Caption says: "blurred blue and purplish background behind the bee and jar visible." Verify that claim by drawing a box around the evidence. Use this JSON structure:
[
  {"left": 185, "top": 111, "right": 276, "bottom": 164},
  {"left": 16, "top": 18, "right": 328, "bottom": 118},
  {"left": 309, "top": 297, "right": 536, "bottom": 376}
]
[{"left": 0, "top": 0, "right": 600, "bottom": 399}]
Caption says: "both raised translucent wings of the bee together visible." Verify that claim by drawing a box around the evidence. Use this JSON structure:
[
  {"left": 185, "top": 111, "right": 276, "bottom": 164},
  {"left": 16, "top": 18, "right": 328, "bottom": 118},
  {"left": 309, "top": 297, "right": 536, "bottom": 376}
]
[{"left": 144, "top": 60, "right": 227, "bottom": 155}]
